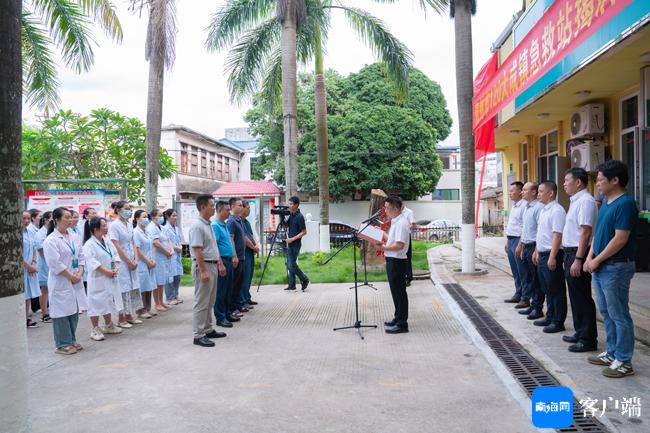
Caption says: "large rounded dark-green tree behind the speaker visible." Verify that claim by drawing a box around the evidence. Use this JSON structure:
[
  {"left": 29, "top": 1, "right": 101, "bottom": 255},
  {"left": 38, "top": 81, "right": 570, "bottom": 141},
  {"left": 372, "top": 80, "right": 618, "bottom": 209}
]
[{"left": 246, "top": 64, "right": 451, "bottom": 200}]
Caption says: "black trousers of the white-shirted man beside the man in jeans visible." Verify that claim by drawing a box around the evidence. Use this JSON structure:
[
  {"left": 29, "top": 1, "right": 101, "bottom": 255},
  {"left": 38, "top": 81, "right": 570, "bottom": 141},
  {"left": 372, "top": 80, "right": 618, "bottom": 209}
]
[{"left": 564, "top": 251, "right": 598, "bottom": 346}]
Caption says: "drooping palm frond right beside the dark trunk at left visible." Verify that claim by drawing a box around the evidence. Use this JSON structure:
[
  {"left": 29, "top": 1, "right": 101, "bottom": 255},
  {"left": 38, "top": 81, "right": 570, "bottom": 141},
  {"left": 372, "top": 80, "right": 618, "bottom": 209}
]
[{"left": 21, "top": 12, "right": 60, "bottom": 111}]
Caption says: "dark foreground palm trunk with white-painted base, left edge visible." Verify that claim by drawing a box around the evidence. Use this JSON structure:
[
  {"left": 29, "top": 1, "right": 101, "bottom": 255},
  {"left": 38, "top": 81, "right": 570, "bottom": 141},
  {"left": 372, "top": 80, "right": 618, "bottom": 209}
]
[{"left": 0, "top": 0, "right": 28, "bottom": 432}]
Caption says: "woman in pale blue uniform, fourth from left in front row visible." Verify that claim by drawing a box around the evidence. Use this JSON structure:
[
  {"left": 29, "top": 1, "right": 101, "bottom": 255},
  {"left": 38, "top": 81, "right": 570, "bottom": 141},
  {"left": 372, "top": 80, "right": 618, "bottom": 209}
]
[{"left": 133, "top": 209, "right": 158, "bottom": 319}]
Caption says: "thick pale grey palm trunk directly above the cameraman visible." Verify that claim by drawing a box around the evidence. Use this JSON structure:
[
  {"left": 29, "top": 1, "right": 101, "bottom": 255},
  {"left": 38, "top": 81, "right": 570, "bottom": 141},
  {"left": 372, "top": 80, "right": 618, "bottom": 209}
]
[{"left": 281, "top": 0, "right": 298, "bottom": 199}]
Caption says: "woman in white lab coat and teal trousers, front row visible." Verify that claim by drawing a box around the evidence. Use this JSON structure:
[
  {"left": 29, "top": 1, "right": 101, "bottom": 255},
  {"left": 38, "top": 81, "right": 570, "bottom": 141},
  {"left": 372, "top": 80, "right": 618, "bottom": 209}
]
[{"left": 43, "top": 207, "right": 84, "bottom": 355}]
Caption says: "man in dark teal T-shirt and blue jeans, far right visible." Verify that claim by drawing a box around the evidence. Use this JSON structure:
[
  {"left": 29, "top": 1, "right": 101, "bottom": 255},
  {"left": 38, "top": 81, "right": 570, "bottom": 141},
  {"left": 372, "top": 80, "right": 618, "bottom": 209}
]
[{"left": 584, "top": 160, "right": 639, "bottom": 378}]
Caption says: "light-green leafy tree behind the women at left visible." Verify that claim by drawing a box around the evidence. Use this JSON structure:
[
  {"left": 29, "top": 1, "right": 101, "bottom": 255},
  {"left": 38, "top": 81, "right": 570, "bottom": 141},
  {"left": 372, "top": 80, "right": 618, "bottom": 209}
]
[{"left": 22, "top": 108, "right": 176, "bottom": 203}]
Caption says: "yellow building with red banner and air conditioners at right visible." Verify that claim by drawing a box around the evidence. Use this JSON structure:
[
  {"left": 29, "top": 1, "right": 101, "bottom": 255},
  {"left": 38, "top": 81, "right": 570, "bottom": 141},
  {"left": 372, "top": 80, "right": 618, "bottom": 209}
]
[{"left": 473, "top": 0, "right": 650, "bottom": 210}]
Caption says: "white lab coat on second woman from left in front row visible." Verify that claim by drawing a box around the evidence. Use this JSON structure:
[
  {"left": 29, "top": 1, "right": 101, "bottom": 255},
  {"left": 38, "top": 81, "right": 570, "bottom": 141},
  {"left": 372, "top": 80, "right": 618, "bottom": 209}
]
[{"left": 83, "top": 236, "right": 124, "bottom": 316}]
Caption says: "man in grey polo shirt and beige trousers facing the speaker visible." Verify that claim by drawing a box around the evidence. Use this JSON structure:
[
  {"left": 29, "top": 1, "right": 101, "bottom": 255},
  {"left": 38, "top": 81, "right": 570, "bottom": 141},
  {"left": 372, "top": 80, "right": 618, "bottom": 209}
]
[{"left": 189, "top": 194, "right": 226, "bottom": 347}]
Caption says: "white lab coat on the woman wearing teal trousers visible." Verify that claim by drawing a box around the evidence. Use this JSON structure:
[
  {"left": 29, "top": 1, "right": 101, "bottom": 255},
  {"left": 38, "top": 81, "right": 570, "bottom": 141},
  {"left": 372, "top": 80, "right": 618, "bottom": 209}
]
[{"left": 43, "top": 230, "right": 88, "bottom": 318}]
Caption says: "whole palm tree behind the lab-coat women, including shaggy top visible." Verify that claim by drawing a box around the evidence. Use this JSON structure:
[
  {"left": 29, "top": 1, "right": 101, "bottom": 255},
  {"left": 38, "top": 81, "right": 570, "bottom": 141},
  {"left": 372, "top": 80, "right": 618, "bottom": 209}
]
[{"left": 131, "top": 0, "right": 177, "bottom": 209}]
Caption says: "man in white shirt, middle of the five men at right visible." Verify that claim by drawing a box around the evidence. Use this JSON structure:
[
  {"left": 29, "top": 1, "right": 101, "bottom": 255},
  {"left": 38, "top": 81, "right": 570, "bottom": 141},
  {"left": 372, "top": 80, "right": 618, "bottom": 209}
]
[{"left": 533, "top": 180, "right": 567, "bottom": 334}]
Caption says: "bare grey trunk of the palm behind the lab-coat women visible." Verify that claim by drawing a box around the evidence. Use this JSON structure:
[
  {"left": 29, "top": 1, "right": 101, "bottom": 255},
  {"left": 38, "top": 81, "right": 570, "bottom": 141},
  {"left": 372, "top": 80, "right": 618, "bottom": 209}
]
[{"left": 145, "top": 31, "right": 165, "bottom": 209}]
